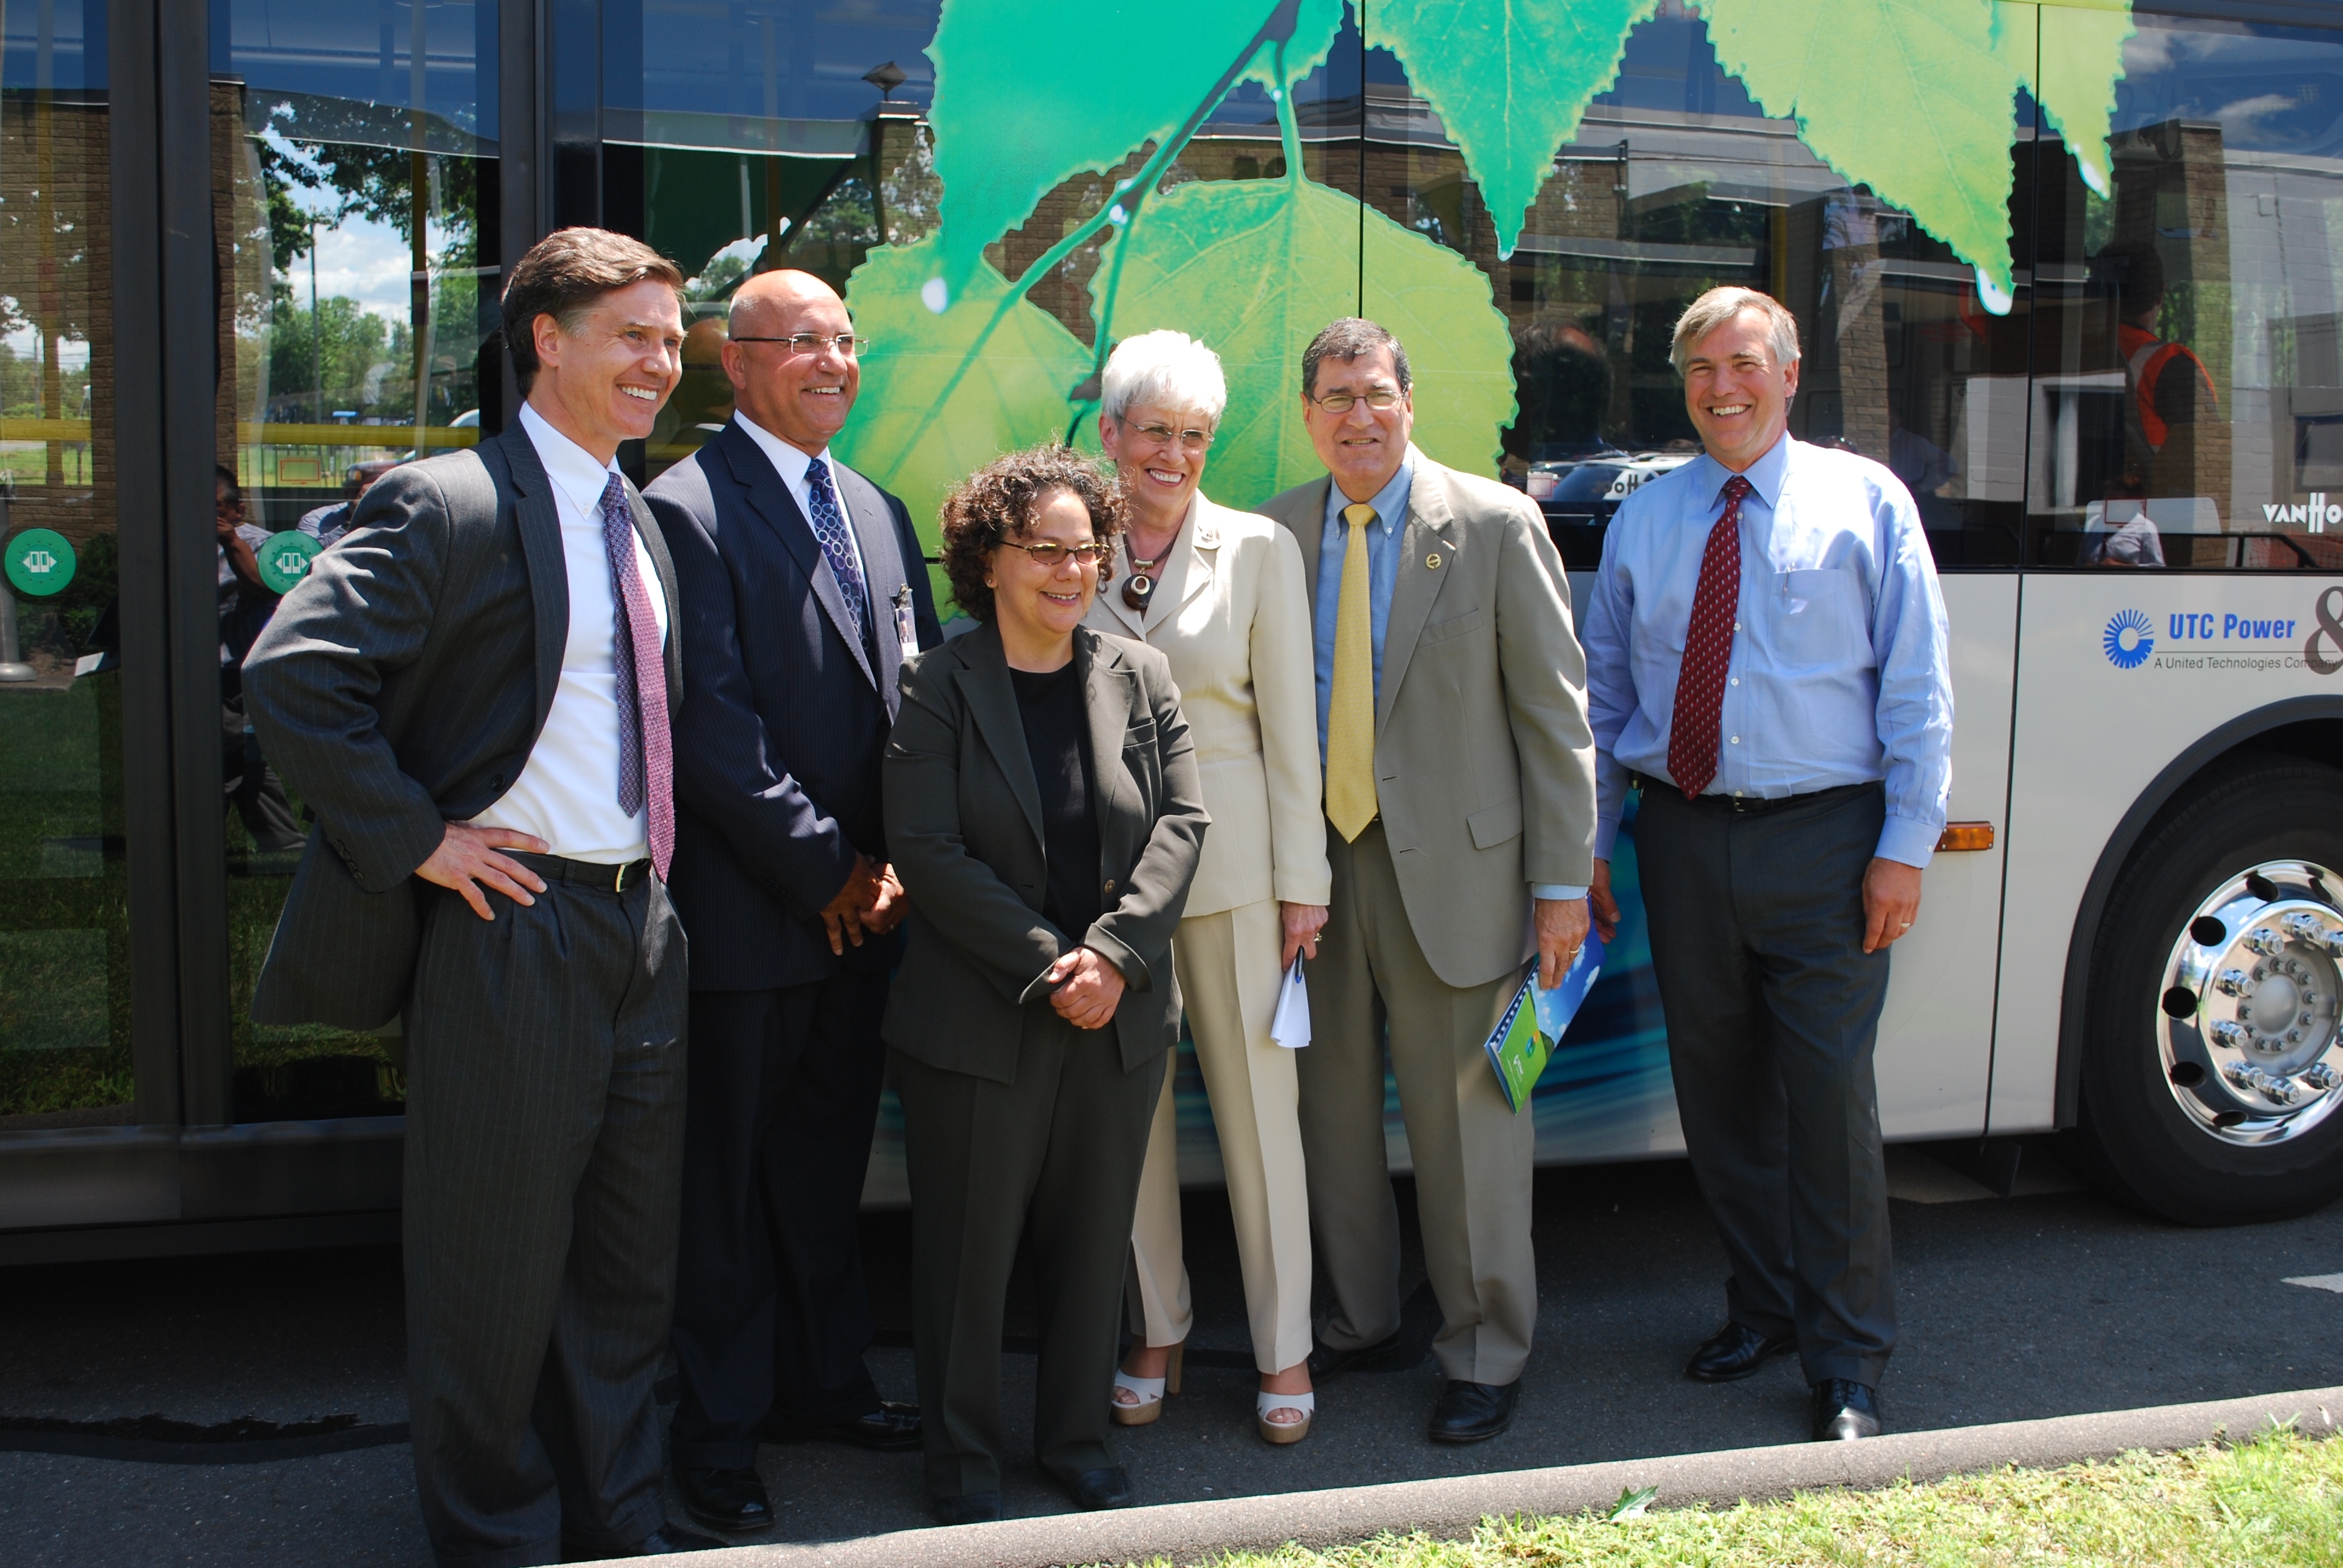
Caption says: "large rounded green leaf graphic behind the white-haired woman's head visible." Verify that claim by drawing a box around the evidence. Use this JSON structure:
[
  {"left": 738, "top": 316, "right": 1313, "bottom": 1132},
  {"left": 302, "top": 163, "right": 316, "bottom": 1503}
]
[{"left": 1094, "top": 178, "right": 1513, "bottom": 506}]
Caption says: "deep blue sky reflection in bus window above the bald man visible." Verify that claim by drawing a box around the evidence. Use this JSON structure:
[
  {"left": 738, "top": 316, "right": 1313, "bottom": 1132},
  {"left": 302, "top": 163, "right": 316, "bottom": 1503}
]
[{"left": 623, "top": 0, "right": 940, "bottom": 120}]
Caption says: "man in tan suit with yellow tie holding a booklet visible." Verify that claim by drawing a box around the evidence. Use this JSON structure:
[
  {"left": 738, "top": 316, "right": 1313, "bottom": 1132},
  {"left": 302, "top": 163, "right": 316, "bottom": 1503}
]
[{"left": 1260, "top": 319, "right": 1596, "bottom": 1444}]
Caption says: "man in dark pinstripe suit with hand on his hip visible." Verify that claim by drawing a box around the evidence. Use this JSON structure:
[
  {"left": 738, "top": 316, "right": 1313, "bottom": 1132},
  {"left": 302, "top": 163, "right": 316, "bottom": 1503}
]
[{"left": 246, "top": 230, "right": 715, "bottom": 1568}]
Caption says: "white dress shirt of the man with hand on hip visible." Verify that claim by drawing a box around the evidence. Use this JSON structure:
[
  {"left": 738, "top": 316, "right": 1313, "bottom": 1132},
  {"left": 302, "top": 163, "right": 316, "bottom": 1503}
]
[{"left": 471, "top": 403, "right": 668, "bottom": 865}]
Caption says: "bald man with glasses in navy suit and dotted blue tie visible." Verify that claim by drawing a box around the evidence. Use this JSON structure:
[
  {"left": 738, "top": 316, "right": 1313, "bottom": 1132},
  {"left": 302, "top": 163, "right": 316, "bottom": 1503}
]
[{"left": 644, "top": 272, "right": 942, "bottom": 1530}]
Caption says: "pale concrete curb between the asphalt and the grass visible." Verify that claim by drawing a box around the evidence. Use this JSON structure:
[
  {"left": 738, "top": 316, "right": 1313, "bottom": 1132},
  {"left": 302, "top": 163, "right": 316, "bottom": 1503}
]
[{"left": 665, "top": 1388, "right": 2343, "bottom": 1568}]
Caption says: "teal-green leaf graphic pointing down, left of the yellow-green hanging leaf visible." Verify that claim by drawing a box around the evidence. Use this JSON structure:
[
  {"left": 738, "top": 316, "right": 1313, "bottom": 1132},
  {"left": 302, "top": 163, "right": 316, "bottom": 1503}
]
[{"left": 1366, "top": 0, "right": 1659, "bottom": 258}]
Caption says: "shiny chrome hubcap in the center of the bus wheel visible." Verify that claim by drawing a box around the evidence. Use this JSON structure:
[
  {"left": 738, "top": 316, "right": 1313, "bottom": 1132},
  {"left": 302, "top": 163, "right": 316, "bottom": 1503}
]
[{"left": 2158, "top": 860, "right": 2343, "bottom": 1146}]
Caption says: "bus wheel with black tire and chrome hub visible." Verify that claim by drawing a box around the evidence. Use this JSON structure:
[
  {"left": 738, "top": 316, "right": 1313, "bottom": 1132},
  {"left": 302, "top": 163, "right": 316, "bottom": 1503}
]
[{"left": 2078, "top": 753, "right": 2343, "bottom": 1226}]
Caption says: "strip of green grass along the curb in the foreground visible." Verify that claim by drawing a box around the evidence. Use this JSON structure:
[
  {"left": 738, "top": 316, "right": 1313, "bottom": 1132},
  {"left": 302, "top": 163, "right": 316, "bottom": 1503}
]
[{"left": 1115, "top": 1429, "right": 2343, "bottom": 1568}]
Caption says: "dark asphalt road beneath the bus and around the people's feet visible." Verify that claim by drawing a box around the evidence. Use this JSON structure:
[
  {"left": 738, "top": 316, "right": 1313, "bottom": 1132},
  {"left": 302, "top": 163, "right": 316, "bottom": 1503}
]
[{"left": 0, "top": 1146, "right": 2343, "bottom": 1568}]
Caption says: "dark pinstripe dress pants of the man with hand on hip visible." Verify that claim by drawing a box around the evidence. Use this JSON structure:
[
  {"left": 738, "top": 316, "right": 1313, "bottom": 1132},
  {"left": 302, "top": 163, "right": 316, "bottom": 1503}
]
[{"left": 403, "top": 855, "right": 686, "bottom": 1568}]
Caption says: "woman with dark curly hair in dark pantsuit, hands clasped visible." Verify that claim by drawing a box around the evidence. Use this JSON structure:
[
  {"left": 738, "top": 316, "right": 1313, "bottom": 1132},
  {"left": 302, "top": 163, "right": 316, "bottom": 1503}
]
[{"left": 883, "top": 448, "right": 1207, "bottom": 1523}]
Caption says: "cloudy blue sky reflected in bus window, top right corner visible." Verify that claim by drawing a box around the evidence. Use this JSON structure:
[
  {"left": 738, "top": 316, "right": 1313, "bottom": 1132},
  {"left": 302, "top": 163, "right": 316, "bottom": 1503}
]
[{"left": 2114, "top": 16, "right": 2343, "bottom": 157}]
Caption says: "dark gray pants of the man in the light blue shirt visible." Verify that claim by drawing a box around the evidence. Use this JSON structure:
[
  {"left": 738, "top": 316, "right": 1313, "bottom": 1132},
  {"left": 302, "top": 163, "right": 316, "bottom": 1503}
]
[{"left": 1636, "top": 780, "right": 1895, "bottom": 1388}]
